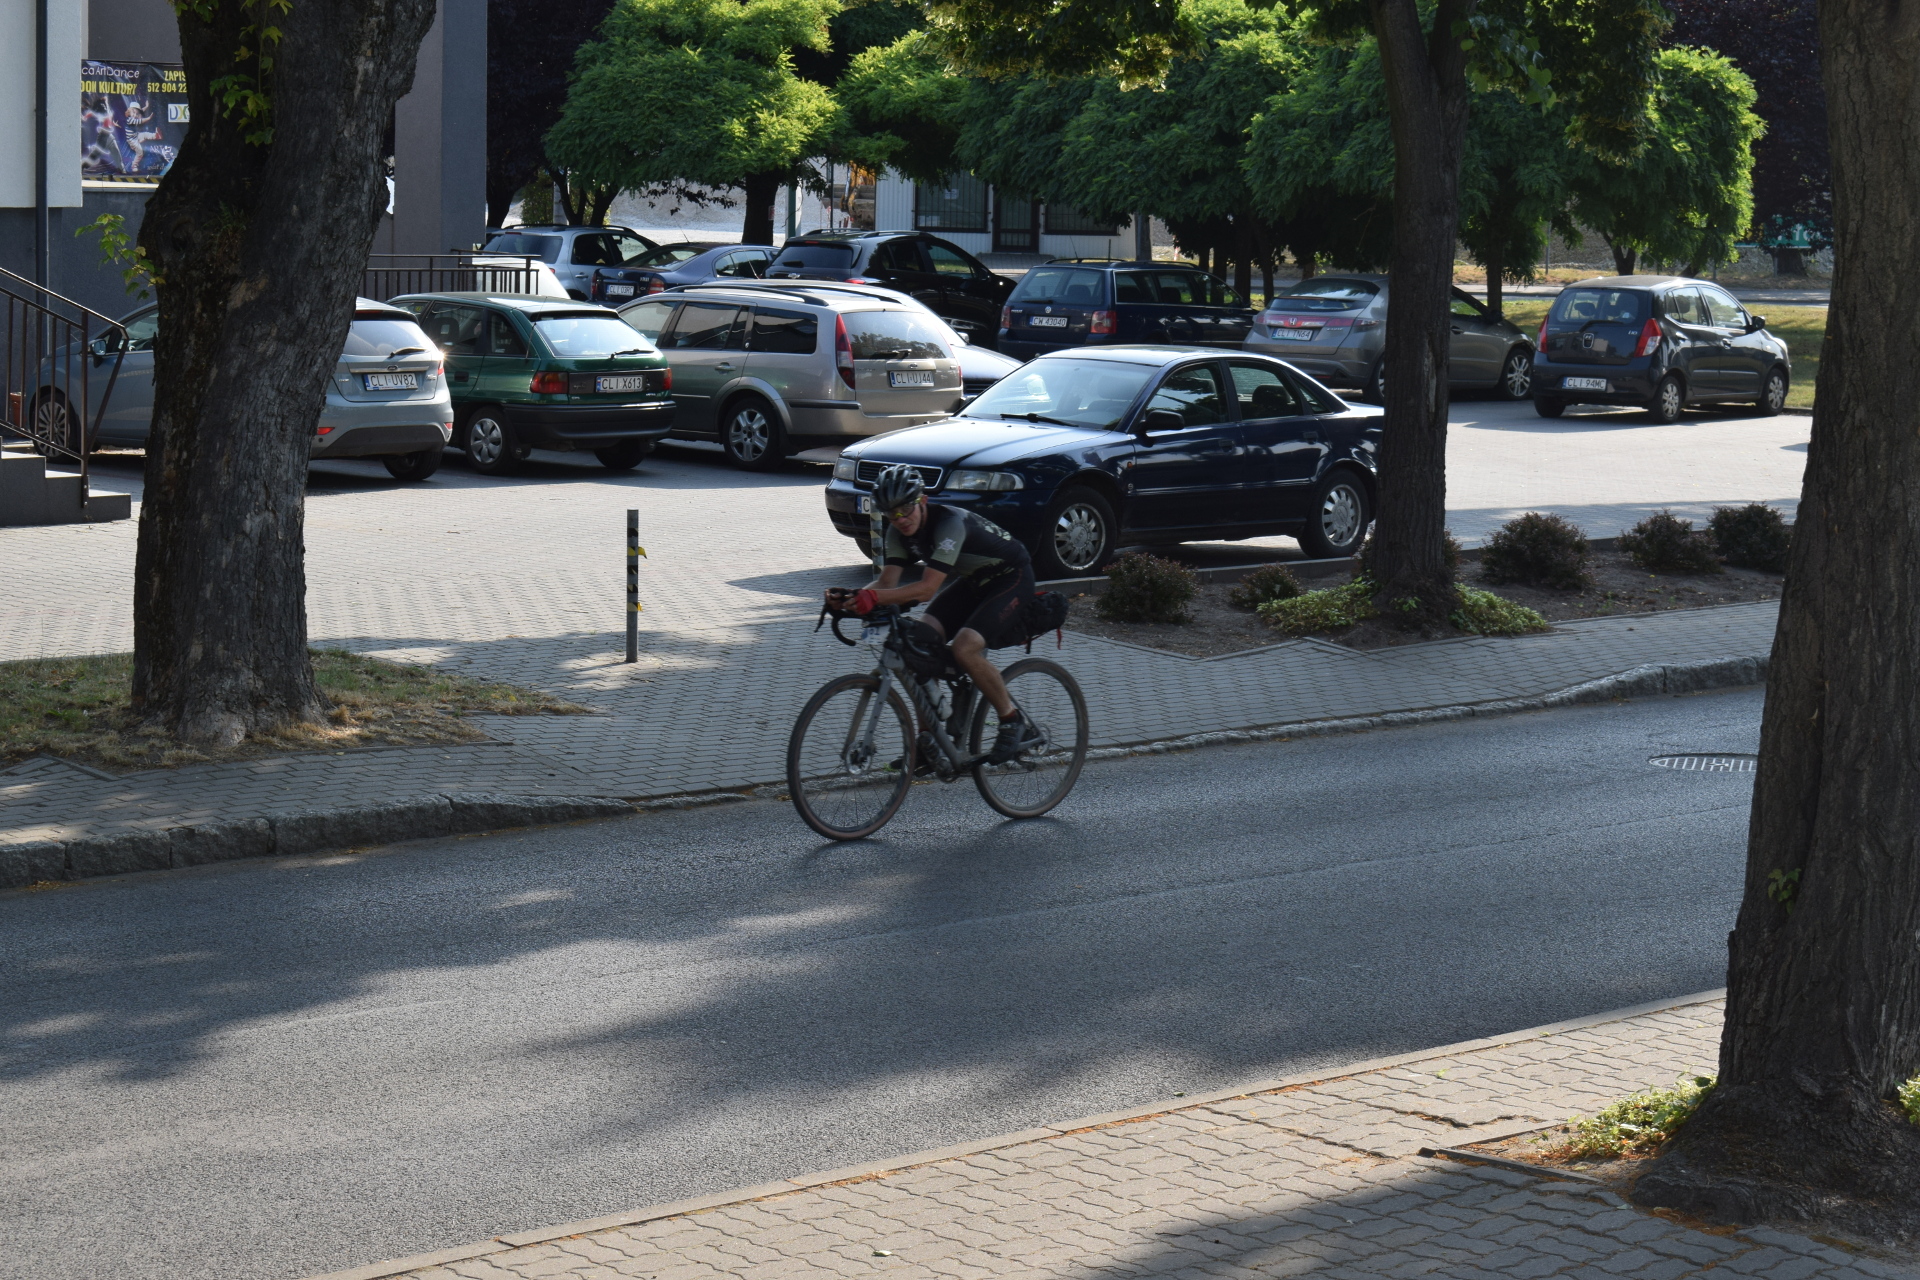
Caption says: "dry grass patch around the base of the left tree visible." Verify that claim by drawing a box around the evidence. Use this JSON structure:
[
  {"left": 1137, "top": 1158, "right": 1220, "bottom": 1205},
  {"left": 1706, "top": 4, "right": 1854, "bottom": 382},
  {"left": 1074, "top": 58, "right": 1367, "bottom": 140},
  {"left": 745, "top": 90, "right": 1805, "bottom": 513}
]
[{"left": 0, "top": 649, "right": 588, "bottom": 771}]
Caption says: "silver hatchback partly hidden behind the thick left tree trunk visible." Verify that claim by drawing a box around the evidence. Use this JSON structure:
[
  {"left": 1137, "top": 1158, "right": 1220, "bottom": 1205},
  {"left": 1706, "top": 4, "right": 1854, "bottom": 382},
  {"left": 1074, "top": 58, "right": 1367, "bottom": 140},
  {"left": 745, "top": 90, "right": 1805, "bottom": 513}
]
[{"left": 35, "top": 297, "right": 453, "bottom": 480}]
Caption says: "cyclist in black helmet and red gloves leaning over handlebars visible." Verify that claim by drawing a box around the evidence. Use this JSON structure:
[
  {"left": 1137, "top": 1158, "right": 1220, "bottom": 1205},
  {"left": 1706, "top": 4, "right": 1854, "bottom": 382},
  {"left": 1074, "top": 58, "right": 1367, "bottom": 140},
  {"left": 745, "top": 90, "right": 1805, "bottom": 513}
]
[{"left": 828, "top": 466, "right": 1041, "bottom": 764}]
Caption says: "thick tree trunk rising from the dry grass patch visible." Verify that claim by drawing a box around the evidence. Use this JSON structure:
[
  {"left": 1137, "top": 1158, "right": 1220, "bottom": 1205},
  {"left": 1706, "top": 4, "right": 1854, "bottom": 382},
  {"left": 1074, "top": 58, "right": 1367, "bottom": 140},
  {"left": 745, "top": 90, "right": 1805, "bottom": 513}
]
[{"left": 132, "top": 0, "right": 434, "bottom": 743}]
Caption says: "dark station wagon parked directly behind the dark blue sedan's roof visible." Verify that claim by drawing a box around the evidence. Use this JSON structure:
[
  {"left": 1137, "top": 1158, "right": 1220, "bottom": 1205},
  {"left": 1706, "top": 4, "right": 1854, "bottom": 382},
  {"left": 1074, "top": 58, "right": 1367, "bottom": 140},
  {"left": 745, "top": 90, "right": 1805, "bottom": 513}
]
[{"left": 1000, "top": 259, "right": 1254, "bottom": 359}]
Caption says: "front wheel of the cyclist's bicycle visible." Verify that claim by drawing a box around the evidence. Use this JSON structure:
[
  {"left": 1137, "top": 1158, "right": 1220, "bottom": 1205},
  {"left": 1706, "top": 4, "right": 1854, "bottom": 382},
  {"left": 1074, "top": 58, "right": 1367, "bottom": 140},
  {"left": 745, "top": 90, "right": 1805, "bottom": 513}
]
[{"left": 787, "top": 676, "right": 914, "bottom": 841}]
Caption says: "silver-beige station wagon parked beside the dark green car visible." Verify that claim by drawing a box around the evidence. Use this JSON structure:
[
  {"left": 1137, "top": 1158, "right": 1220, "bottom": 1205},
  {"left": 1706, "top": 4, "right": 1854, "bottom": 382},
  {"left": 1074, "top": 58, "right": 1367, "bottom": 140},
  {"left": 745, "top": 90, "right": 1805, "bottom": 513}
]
[{"left": 620, "top": 282, "right": 964, "bottom": 470}]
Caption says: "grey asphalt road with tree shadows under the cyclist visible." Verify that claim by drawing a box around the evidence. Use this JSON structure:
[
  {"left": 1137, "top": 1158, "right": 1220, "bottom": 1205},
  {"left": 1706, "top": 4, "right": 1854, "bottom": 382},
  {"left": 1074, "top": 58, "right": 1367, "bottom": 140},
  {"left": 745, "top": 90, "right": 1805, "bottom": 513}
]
[{"left": 0, "top": 691, "right": 1761, "bottom": 1280}]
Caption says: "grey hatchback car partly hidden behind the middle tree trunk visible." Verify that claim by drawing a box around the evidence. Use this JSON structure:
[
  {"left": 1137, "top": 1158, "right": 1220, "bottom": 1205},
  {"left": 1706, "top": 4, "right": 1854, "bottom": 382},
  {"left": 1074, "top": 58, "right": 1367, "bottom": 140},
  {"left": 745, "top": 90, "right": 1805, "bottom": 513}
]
[{"left": 1244, "top": 274, "right": 1534, "bottom": 403}]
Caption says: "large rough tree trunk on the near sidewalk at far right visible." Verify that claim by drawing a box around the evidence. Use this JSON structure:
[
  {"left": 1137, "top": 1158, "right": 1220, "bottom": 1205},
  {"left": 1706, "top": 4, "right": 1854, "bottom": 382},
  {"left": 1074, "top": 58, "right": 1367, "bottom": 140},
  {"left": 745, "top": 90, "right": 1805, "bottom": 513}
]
[{"left": 1634, "top": 0, "right": 1920, "bottom": 1242}]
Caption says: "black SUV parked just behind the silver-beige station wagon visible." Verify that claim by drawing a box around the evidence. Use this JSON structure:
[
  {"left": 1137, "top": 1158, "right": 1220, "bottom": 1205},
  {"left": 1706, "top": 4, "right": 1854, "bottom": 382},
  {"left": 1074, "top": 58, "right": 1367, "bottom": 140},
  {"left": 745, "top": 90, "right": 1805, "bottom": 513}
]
[{"left": 766, "top": 230, "right": 1014, "bottom": 347}]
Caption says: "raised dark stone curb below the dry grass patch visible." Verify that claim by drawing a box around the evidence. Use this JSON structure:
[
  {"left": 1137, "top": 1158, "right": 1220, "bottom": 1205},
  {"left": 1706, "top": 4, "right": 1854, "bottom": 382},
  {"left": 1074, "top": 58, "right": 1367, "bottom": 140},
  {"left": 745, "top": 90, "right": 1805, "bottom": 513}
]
[{"left": 0, "top": 793, "right": 634, "bottom": 889}]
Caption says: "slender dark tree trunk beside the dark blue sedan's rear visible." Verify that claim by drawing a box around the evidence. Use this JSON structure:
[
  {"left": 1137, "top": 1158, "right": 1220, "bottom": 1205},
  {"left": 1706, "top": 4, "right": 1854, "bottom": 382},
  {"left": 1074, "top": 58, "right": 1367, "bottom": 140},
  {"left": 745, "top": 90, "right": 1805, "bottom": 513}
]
[{"left": 1369, "top": 0, "right": 1476, "bottom": 629}]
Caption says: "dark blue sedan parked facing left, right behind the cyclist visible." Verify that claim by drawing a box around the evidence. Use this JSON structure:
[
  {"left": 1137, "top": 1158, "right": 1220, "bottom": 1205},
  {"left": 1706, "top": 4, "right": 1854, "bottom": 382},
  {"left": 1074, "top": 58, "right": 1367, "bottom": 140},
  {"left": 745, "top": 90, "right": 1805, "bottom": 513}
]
[{"left": 826, "top": 345, "right": 1380, "bottom": 580}]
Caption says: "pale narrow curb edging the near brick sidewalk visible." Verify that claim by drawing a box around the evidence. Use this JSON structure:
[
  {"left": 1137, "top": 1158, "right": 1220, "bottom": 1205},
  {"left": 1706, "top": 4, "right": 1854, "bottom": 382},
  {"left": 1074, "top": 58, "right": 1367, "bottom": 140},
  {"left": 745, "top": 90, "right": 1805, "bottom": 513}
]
[{"left": 305, "top": 988, "right": 1726, "bottom": 1280}]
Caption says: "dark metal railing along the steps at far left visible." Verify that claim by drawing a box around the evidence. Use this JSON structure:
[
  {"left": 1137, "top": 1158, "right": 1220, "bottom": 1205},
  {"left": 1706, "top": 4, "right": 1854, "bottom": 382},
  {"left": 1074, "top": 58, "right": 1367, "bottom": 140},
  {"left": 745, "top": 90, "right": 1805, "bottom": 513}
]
[{"left": 0, "top": 267, "right": 127, "bottom": 507}]
